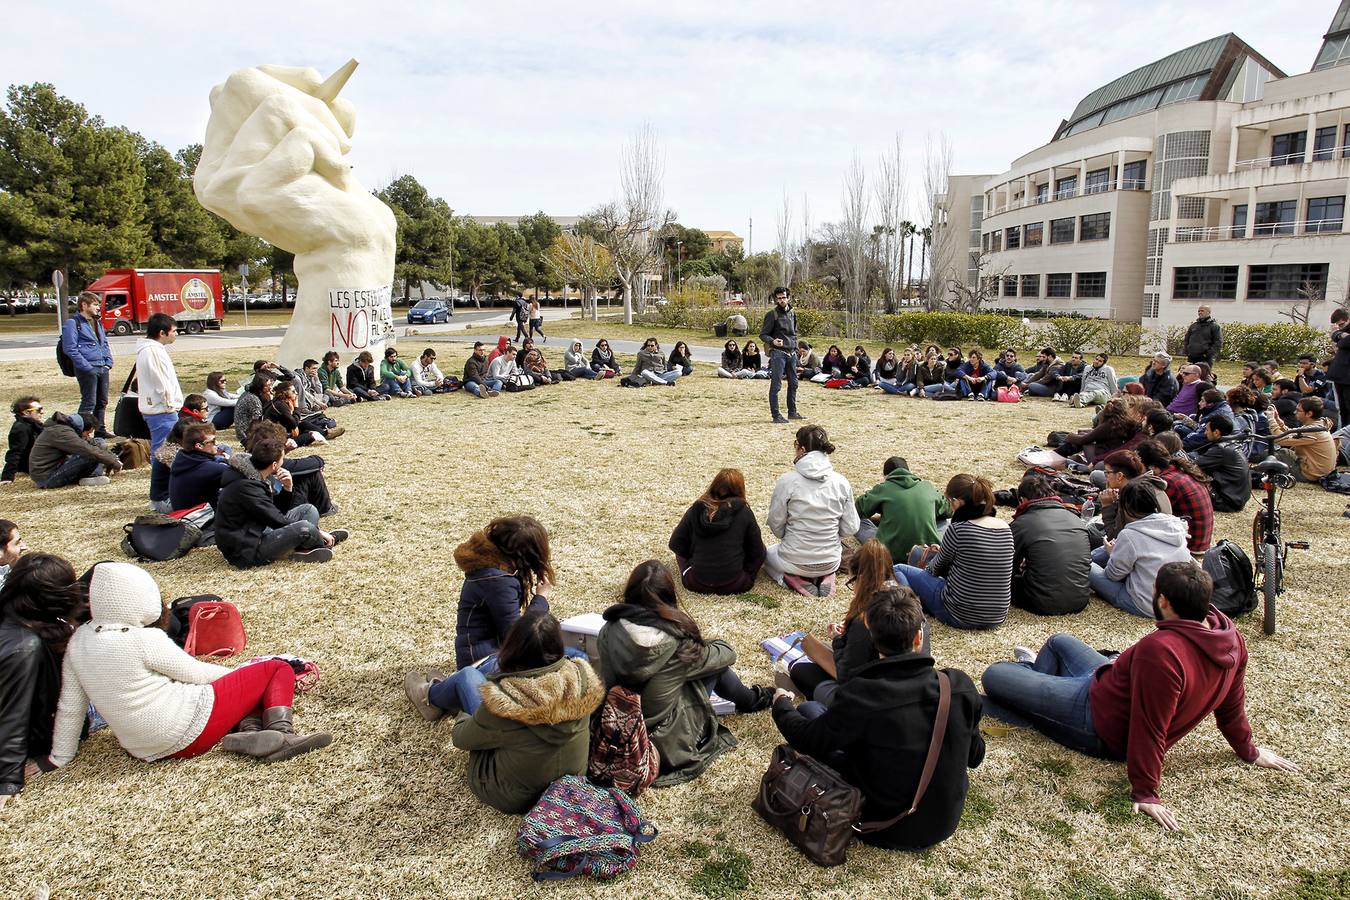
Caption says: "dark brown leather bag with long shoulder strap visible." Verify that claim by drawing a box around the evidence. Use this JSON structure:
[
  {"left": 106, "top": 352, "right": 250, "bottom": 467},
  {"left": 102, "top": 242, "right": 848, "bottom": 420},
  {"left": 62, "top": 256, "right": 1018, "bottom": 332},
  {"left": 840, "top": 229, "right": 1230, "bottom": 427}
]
[{"left": 752, "top": 669, "right": 952, "bottom": 866}]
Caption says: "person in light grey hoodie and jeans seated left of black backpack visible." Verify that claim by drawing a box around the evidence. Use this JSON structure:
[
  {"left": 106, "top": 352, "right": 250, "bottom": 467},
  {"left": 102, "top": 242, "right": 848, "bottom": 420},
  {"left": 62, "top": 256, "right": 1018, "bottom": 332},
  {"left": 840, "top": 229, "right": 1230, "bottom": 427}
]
[{"left": 1088, "top": 482, "right": 1195, "bottom": 618}]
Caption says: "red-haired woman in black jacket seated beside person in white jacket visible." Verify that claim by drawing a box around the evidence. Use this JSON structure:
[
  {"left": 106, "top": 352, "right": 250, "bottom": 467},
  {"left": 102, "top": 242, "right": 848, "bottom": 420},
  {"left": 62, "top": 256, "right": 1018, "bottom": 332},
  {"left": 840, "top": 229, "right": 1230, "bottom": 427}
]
[{"left": 670, "top": 468, "right": 765, "bottom": 594}]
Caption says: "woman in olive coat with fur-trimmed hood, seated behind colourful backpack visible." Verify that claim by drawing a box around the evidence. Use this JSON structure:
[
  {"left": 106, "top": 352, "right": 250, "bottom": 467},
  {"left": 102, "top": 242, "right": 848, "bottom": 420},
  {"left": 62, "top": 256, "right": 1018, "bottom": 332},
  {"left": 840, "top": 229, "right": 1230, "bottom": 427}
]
[{"left": 451, "top": 611, "right": 605, "bottom": 815}]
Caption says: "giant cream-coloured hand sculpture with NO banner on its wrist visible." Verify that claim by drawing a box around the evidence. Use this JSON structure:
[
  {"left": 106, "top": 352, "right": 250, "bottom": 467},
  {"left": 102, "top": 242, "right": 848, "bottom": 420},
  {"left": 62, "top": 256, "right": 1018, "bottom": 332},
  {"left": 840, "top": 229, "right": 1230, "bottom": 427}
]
[{"left": 193, "top": 59, "right": 397, "bottom": 366}]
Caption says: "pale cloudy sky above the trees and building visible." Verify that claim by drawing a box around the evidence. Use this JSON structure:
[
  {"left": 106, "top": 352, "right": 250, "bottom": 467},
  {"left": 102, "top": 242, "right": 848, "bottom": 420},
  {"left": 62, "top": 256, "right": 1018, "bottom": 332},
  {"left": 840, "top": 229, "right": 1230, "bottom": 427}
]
[{"left": 0, "top": 0, "right": 1337, "bottom": 250}]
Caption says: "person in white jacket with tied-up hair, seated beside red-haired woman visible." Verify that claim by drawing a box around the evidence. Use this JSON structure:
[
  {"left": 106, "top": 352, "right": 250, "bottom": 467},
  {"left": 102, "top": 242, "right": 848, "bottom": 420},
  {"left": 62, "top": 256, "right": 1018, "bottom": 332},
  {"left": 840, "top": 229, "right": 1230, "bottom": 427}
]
[{"left": 764, "top": 425, "right": 859, "bottom": 596}]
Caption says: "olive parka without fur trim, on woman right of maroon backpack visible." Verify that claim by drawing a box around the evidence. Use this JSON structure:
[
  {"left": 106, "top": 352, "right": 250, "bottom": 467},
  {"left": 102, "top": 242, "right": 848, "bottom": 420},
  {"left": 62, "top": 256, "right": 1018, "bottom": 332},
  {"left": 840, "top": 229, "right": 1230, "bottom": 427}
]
[{"left": 599, "top": 603, "right": 736, "bottom": 787}]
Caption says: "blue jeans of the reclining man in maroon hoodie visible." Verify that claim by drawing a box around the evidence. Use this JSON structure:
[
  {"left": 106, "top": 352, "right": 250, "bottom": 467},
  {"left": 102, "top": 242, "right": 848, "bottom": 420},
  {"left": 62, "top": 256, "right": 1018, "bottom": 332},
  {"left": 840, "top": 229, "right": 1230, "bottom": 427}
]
[{"left": 980, "top": 634, "right": 1108, "bottom": 757}]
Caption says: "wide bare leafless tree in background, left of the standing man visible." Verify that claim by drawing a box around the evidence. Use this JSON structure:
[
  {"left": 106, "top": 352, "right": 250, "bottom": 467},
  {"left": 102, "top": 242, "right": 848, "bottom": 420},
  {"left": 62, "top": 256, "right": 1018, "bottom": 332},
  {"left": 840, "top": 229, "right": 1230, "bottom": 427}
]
[{"left": 590, "top": 124, "right": 675, "bottom": 325}]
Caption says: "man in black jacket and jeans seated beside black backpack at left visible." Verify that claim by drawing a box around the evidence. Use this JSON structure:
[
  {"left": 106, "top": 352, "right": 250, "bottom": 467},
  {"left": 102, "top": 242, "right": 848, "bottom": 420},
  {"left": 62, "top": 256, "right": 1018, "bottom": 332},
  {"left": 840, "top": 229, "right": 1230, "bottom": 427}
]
[{"left": 216, "top": 441, "right": 347, "bottom": 568}]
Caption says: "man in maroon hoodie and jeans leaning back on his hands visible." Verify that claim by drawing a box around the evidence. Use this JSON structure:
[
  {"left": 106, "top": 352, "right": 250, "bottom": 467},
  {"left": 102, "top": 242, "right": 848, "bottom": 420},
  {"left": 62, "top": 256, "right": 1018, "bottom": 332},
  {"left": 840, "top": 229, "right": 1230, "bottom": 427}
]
[{"left": 980, "top": 563, "right": 1299, "bottom": 831}]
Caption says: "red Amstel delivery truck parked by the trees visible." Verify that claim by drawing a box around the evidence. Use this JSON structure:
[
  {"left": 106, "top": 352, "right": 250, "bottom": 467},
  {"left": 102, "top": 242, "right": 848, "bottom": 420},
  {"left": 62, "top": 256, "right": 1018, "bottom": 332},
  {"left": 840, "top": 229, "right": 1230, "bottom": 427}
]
[{"left": 85, "top": 269, "right": 225, "bottom": 335}]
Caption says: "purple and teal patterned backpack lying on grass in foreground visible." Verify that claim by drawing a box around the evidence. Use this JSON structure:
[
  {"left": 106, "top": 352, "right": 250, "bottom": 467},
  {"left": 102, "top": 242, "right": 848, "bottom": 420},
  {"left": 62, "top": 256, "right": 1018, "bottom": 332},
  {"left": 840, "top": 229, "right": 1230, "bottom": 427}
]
[{"left": 516, "top": 775, "right": 656, "bottom": 881}]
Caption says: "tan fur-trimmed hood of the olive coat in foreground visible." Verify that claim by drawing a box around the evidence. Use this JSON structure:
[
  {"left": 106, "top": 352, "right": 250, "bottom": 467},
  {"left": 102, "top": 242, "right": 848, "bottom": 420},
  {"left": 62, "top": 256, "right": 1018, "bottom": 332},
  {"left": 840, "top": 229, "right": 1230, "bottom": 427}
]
[{"left": 482, "top": 657, "right": 605, "bottom": 726}]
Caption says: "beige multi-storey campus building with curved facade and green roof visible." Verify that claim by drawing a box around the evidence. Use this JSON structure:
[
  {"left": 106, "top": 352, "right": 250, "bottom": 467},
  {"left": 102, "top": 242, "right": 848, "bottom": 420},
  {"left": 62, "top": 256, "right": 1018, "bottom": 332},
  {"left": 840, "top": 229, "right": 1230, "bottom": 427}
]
[{"left": 936, "top": 0, "right": 1350, "bottom": 325}]
